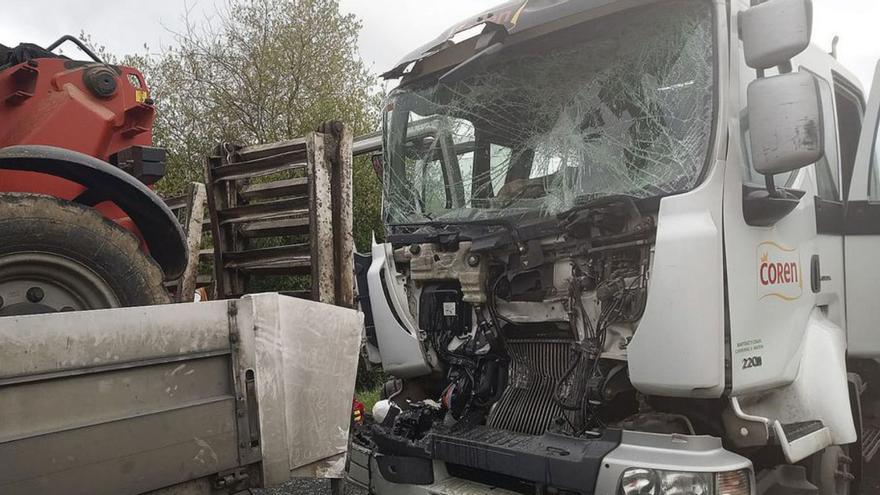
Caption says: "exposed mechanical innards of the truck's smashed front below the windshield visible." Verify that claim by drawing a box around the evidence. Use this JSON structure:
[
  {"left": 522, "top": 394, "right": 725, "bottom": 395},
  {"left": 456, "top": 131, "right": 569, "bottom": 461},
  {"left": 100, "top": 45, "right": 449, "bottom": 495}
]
[{"left": 376, "top": 197, "right": 668, "bottom": 446}]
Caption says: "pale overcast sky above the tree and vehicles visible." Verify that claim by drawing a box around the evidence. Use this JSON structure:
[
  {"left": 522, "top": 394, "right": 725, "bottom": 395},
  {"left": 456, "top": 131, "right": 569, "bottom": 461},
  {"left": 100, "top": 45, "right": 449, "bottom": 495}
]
[{"left": 0, "top": 0, "right": 880, "bottom": 87}]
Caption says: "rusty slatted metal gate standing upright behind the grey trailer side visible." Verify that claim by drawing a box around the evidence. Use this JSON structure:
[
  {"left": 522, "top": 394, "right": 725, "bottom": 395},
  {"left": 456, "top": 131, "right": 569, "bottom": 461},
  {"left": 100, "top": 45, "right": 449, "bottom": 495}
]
[{"left": 205, "top": 122, "right": 354, "bottom": 307}]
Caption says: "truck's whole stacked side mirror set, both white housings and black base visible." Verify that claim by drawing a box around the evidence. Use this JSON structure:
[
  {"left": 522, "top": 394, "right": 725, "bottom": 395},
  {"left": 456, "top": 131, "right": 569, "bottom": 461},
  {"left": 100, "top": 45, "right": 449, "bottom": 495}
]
[{"left": 739, "top": 0, "right": 825, "bottom": 226}]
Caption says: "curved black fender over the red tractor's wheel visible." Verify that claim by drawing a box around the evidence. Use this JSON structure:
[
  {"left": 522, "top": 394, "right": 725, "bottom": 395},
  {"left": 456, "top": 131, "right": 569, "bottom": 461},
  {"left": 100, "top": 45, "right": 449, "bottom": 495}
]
[{"left": 0, "top": 145, "right": 188, "bottom": 280}]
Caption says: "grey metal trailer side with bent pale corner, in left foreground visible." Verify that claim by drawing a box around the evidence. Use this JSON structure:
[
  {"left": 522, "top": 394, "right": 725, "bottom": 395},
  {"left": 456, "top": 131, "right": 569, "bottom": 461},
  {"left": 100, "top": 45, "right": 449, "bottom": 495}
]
[{"left": 0, "top": 294, "right": 362, "bottom": 495}]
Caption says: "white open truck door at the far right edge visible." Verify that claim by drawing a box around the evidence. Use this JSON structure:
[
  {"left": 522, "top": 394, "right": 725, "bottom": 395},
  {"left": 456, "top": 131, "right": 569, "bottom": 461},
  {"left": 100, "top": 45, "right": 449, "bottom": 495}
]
[{"left": 841, "top": 65, "right": 880, "bottom": 358}]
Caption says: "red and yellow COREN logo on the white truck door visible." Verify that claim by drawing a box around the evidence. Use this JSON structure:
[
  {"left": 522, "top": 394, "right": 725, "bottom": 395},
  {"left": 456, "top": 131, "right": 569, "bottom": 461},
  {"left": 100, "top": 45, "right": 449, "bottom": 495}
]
[{"left": 758, "top": 242, "right": 804, "bottom": 301}]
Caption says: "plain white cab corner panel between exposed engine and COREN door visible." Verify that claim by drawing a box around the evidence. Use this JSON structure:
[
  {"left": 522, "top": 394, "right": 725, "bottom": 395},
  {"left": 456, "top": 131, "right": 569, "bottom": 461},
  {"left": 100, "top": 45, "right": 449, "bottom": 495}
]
[{"left": 628, "top": 157, "right": 726, "bottom": 397}]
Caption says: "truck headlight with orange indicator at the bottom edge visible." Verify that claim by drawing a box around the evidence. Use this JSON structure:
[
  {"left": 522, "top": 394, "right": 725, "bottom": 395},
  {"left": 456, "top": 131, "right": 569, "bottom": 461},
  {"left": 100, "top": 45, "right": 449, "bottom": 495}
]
[{"left": 620, "top": 468, "right": 751, "bottom": 495}]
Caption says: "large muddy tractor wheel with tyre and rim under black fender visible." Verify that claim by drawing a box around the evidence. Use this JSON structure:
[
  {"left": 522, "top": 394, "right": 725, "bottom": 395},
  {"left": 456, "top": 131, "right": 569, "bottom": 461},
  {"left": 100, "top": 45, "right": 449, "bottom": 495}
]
[{"left": 0, "top": 193, "right": 170, "bottom": 317}]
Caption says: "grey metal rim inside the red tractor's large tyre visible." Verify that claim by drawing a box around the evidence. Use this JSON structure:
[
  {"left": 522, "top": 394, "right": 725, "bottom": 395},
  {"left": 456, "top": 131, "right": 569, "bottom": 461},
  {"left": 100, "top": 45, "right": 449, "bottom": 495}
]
[{"left": 0, "top": 253, "right": 120, "bottom": 316}]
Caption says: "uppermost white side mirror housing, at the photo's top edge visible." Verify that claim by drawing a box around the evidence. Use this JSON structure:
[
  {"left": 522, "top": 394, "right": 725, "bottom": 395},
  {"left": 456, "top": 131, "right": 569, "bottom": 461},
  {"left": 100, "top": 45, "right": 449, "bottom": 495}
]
[{"left": 739, "top": 0, "right": 813, "bottom": 71}]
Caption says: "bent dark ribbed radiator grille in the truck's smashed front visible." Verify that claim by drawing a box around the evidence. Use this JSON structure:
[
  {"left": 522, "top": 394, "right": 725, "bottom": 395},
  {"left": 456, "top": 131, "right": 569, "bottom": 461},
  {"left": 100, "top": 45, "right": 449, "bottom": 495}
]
[{"left": 487, "top": 339, "right": 572, "bottom": 435}]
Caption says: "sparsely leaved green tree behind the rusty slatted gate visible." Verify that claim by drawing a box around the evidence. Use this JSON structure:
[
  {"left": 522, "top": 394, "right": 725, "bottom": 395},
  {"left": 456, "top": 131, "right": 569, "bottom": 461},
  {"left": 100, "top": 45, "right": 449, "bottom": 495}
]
[{"left": 138, "top": 0, "right": 382, "bottom": 249}]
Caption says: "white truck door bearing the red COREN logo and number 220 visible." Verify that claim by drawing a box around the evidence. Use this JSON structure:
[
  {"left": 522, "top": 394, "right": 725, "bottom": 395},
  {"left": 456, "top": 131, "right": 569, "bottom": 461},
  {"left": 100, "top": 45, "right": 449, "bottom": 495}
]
[{"left": 724, "top": 55, "right": 845, "bottom": 395}]
